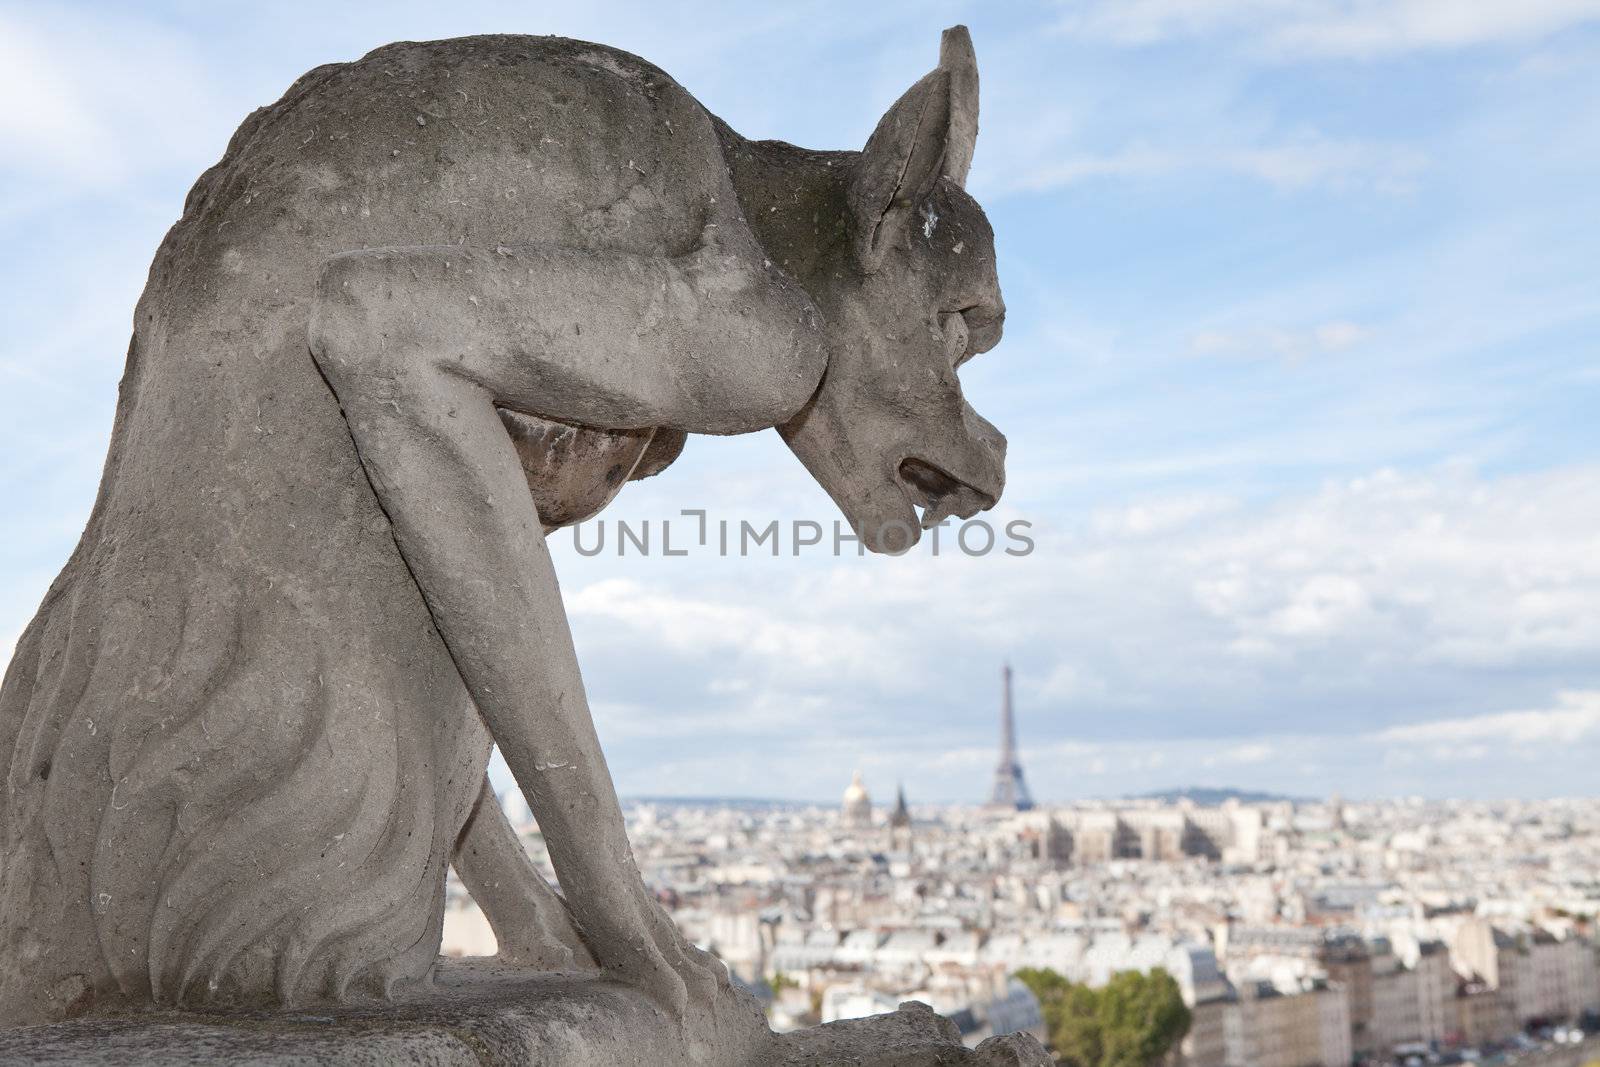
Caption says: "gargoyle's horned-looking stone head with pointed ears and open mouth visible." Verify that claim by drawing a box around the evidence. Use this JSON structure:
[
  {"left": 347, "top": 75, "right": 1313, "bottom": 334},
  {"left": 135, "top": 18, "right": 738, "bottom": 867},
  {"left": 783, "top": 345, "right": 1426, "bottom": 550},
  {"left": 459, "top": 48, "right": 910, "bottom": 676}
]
[{"left": 778, "top": 26, "right": 1005, "bottom": 552}]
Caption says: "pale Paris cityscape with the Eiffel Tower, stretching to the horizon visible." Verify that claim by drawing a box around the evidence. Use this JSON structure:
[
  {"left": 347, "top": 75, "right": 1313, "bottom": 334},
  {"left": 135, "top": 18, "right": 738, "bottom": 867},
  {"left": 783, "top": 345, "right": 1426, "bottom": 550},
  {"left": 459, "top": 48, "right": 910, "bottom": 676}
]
[{"left": 443, "top": 667, "right": 1600, "bottom": 1067}]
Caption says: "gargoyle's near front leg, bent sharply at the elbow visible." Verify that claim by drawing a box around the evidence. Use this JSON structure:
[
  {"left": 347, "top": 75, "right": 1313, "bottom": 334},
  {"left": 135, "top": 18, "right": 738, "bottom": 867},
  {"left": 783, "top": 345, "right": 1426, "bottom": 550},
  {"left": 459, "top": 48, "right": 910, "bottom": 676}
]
[{"left": 309, "top": 245, "right": 826, "bottom": 1013}]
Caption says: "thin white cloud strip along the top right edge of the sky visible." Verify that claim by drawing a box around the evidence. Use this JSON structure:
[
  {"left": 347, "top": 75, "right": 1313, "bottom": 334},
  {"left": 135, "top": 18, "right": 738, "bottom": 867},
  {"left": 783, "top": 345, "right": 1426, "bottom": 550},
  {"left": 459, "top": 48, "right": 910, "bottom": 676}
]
[{"left": 1061, "top": 0, "right": 1600, "bottom": 58}]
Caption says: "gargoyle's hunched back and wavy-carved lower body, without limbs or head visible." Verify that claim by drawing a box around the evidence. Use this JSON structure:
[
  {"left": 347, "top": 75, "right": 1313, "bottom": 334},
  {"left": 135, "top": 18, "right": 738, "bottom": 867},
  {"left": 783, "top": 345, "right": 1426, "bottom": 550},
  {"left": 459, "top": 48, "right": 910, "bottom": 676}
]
[{"left": 0, "top": 37, "right": 761, "bottom": 1022}]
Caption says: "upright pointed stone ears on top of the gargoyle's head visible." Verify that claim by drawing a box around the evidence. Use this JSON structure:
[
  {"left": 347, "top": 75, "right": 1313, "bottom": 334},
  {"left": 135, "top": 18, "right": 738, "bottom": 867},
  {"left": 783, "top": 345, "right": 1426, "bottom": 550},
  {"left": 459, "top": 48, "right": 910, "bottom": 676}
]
[{"left": 850, "top": 26, "right": 978, "bottom": 270}]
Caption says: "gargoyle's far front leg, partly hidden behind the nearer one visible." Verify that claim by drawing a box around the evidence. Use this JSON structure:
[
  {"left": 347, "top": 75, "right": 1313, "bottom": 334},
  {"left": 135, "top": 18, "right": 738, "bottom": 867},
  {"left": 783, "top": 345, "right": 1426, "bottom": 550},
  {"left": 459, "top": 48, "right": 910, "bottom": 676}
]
[{"left": 454, "top": 777, "right": 594, "bottom": 971}]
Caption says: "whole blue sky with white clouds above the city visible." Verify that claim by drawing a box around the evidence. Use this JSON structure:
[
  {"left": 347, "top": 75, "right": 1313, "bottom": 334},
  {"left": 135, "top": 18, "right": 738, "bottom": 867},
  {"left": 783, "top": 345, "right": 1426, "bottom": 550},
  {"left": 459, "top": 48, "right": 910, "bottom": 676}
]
[{"left": 0, "top": 0, "right": 1600, "bottom": 800}]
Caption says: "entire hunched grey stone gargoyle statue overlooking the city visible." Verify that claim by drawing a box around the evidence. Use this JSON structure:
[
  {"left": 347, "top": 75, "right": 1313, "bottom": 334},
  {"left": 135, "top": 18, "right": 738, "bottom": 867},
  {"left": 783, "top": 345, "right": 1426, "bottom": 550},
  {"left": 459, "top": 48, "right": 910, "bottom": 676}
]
[{"left": 0, "top": 27, "right": 1005, "bottom": 1062}]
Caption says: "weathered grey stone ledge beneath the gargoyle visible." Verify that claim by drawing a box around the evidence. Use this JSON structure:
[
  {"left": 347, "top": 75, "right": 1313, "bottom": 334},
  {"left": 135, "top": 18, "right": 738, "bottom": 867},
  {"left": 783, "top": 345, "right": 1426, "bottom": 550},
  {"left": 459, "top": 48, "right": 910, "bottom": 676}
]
[{"left": 0, "top": 961, "right": 1050, "bottom": 1067}]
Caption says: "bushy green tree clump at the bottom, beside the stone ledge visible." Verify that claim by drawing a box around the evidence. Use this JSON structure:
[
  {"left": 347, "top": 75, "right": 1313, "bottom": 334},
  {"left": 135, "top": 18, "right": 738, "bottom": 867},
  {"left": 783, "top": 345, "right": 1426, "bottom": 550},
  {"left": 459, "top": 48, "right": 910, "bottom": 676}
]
[{"left": 1016, "top": 968, "right": 1189, "bottom": 1067}]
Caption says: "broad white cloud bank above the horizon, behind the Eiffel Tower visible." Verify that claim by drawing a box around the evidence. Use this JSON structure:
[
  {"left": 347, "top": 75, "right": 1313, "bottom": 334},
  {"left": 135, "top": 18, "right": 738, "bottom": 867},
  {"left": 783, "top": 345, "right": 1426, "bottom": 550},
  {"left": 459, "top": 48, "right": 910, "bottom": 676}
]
[{"left": 547, "top": 466, "right": 1600, "bottom": 795}]
